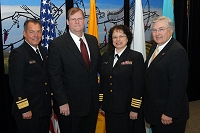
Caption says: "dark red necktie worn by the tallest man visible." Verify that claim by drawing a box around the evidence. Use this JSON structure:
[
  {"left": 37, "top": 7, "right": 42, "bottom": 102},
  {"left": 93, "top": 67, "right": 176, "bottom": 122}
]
[{"left": 80, "top": 38, "right": 90, "bottom": 68}]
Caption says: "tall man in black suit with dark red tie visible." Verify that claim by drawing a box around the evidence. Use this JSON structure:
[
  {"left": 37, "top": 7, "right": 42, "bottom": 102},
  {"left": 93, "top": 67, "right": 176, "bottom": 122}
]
[{"left": 48, "top": 8, "right": 101, "bottom": 133}]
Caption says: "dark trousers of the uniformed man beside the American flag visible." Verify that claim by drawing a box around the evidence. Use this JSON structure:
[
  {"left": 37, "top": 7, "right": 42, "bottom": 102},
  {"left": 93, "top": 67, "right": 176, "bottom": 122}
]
[{"left": 15, "top": 117, "right": 50, "bottom": 133}]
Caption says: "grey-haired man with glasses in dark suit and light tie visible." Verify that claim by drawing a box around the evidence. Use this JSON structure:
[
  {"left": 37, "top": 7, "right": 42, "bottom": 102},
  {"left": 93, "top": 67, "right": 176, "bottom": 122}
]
[{"left": 144, "top": 16, "right": 189, "bottom": 133}]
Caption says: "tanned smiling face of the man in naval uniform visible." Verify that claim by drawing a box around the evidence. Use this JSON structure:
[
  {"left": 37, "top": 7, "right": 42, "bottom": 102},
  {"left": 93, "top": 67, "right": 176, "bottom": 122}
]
[{"left": 23, "top": 22, "right": 42, "bottom": 48}]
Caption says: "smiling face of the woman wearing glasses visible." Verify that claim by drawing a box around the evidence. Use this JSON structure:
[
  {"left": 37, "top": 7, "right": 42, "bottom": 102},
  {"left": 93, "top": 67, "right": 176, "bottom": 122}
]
[{"left": 112, "top": 29, "right": 128, "bottom": 52}]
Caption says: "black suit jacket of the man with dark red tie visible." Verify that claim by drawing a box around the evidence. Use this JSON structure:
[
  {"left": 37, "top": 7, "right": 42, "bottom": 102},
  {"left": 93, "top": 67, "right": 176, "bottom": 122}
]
[{"left": 48, "top": 33, "right": 101, "bottom": 116}]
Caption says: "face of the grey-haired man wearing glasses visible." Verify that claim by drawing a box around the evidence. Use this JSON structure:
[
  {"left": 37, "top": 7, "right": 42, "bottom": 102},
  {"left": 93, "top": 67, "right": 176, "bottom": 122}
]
[{"left": 152, "top": 20, "right": 173, "bottom": 46}]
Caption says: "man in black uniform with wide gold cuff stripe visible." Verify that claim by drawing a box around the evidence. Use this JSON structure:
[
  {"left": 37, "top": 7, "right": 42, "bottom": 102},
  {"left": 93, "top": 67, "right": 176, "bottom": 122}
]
[{"left": 9, "top": 20, "right": 51, "bottom": 133}]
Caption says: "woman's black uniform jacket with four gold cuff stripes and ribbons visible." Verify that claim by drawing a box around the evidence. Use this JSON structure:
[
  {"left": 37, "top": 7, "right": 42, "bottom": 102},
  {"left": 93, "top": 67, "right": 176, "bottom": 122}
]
[{"left": 100, "top": 47, "right": 145, "bottom": 113}]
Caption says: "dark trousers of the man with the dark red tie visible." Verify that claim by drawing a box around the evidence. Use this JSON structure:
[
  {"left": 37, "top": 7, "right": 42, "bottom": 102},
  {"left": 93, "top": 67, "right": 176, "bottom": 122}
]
[{"left": 56, "top": 106, "right": 98, "bottom": 133}]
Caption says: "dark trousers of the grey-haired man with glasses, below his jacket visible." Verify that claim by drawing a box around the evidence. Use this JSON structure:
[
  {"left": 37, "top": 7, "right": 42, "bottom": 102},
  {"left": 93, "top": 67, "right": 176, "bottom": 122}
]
[{"left": 151, "top": 121, "right": 186, "bottom": 133}]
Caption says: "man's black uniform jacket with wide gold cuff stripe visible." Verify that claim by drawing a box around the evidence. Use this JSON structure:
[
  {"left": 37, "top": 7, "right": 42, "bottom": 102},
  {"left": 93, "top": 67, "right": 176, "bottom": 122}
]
[{"left": 9, "top": 41, "right": 51, "bottom": 118}]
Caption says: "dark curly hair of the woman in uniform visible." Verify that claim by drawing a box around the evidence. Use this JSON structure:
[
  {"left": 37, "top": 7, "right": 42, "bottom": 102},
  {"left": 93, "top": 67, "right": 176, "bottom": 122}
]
[{"left": 108, "top": 25, "right": 133, "bottom": 50}]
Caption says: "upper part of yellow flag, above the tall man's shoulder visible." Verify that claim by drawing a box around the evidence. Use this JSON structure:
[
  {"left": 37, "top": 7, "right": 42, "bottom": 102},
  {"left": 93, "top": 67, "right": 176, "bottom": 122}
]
[{"left": 88, "top": 0, "right": 99, "bottom": 40}]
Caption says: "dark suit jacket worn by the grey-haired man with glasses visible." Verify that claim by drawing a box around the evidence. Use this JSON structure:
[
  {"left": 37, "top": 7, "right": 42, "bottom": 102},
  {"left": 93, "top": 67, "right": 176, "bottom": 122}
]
[{"left": 144, "top": 38, "right": 189, "bottom": 125}]
